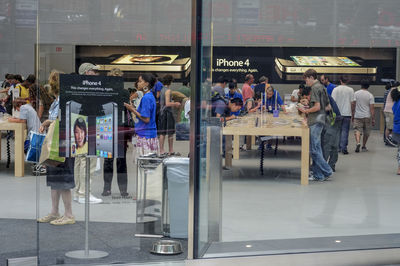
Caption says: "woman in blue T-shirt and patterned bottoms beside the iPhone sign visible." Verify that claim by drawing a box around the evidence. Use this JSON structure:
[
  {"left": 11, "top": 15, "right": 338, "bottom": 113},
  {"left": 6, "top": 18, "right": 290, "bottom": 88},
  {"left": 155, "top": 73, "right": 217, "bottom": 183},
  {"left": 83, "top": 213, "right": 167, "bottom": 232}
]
[{"left": 124, "top": 73, "right": 160, "bottom": 156}]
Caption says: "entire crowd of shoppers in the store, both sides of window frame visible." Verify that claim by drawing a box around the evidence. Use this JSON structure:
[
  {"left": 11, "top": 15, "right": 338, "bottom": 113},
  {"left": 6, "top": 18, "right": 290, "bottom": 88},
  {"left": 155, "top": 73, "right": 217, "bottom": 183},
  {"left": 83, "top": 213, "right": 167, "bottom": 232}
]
[{"left": 0, "top": 63, "right": 400, "bottom": 225}]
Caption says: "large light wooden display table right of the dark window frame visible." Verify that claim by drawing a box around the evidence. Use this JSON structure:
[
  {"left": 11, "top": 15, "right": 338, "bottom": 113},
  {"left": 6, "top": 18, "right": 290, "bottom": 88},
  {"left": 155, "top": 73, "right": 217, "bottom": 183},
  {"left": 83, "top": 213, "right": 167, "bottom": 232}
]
[{"left": 222, "top": 113, "right": 310, "bottom": 185}]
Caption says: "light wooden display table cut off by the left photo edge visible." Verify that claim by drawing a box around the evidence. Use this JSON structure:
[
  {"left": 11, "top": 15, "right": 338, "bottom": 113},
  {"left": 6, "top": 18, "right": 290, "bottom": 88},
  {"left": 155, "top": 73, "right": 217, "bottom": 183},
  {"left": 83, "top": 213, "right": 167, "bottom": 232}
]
[{"left": 0, "top": 120, "right": 26, "bottom": 177}]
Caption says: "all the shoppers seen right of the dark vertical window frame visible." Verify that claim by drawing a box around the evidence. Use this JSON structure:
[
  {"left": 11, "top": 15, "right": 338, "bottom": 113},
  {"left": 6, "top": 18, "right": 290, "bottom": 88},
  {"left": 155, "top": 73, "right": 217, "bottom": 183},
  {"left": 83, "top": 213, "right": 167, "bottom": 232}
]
[{"left": 211, "top": 69, "right": 400, "bottom": 181}]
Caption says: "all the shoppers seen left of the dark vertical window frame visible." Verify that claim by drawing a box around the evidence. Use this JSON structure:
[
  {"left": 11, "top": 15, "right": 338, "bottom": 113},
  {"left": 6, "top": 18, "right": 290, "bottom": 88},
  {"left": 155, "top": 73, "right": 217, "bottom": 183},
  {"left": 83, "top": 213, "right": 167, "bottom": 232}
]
[{"left": 0, "top": 63, "right": 190, "bottom": 225}]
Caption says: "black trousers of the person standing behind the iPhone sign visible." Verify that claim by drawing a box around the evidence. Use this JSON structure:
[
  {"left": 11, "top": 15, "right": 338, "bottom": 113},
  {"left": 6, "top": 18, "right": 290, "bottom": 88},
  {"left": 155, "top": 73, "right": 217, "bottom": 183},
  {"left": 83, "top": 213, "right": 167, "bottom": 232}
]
[{"left": 103, "top": 141, "right": 128, "bottom": 193}]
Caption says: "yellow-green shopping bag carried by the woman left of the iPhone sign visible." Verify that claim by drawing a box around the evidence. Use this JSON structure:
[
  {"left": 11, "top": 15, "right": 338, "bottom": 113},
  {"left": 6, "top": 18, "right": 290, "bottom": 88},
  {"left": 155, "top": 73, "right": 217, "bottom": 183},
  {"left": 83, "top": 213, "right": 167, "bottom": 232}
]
[{"left": 39, "top": 119, "right": 65, "bottom": 166}]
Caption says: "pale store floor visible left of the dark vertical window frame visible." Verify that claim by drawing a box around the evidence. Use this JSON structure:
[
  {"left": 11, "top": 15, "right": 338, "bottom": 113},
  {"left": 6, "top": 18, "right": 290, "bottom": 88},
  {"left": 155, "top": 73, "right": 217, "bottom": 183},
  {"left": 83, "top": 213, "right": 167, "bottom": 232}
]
[{"left": 0, "top": 139, "right": 188, "bottom": 223}]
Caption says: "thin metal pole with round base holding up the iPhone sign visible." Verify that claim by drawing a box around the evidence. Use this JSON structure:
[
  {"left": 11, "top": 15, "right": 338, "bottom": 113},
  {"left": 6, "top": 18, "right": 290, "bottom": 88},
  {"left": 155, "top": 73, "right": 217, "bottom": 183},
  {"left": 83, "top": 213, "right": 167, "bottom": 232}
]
[{"left": 65, "top": 156, "right": 108, "bottom": 259}]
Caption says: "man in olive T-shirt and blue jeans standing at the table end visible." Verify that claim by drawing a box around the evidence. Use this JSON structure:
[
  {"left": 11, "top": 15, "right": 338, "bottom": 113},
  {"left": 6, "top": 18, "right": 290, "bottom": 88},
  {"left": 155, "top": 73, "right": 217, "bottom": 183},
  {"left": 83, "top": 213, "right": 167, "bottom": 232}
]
[{"left": 299, "top": 69, "right": 332, "bottom": 181}]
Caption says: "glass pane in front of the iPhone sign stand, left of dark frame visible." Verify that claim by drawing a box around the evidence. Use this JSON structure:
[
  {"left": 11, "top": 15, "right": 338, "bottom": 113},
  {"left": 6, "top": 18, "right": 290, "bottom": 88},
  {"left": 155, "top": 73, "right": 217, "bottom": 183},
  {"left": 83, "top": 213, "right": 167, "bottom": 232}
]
[{"left": 36, "top": 0, "right": 190, "bottom": 265}]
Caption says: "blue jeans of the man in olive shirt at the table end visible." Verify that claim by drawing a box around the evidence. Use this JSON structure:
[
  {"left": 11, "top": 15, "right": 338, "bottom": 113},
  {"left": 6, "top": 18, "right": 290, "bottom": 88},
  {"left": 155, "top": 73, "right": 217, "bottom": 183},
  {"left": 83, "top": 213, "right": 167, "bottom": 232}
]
[{"left": 310, "top": 123, "right": 332, "bottom": 179}]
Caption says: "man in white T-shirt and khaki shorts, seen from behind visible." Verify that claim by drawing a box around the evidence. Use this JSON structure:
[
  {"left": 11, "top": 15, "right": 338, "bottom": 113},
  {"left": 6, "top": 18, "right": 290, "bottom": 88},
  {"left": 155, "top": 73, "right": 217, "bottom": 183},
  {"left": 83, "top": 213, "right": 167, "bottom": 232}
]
[{"left": 351, "top": 81, "right": 375, "bottom": 152}]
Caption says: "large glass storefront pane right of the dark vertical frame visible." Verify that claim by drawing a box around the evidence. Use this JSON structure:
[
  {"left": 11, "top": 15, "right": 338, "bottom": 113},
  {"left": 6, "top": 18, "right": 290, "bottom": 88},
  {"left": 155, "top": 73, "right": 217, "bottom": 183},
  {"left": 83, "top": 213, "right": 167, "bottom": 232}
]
[{"left": 193, "top": 0, "right": 400, "bottom": 258}]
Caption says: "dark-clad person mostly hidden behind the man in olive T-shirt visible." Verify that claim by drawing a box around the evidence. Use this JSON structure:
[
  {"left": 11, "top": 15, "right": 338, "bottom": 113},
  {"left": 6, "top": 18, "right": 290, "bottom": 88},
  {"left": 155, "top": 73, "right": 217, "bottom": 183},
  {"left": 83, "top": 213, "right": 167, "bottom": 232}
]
[{"left": 321, "top": 90, "right": 342, "bottom": 172}]
